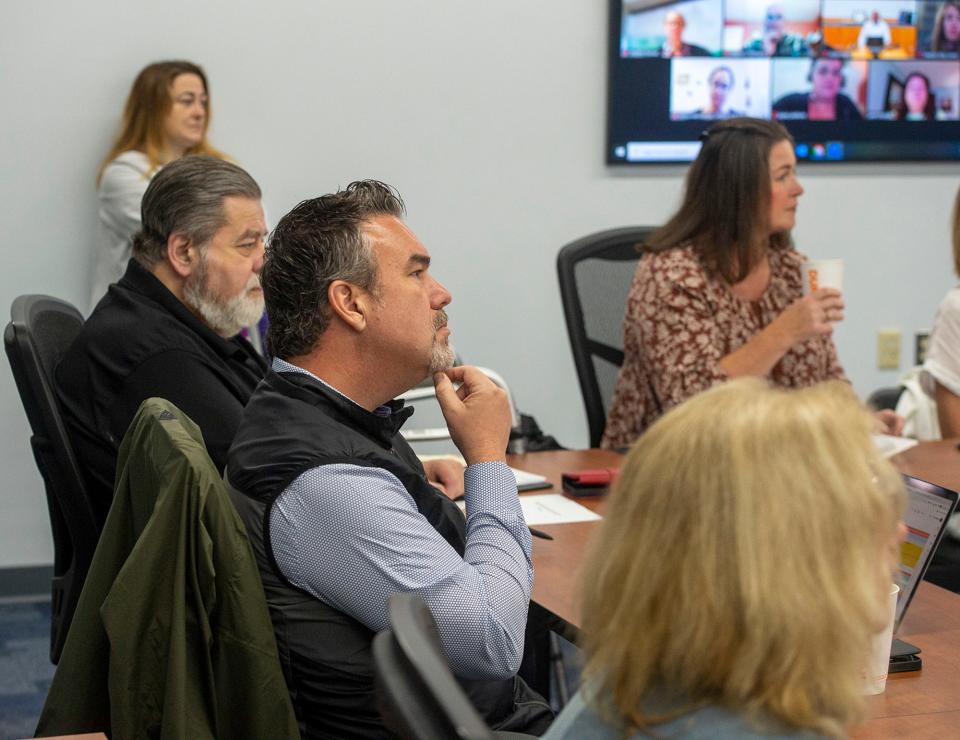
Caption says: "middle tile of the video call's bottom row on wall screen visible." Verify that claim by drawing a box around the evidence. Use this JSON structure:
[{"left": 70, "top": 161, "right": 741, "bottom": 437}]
[{"left": 772, "top": 57, "right": 867, "bottom": 121}]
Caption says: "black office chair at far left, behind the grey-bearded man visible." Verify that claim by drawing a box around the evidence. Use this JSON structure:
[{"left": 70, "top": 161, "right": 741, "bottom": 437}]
[{"left": 3, "top": 295, "right": 100, "bottom": 664}]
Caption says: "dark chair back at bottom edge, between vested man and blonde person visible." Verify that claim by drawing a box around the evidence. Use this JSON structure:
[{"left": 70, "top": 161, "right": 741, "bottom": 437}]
[{"left": 373, "top": 594, "right": 534, "bottom": 740}]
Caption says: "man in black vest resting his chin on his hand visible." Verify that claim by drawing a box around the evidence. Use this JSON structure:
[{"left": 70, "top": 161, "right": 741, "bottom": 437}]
[{"left": 227, "top": 180, "right": 553, "bottom": 740}]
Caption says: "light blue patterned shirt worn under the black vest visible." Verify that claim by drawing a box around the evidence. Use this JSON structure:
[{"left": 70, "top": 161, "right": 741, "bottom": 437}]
[{"left": 270, "top": 359, "right": 533, "bottom": 679}]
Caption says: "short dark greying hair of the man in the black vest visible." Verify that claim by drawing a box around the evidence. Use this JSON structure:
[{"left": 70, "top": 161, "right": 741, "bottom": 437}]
[{"left": 260, "top": 180, "right": 405, "bottom": 359}]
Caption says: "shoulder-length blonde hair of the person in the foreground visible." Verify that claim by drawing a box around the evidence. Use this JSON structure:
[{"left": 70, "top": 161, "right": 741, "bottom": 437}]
[{"left": 582, "top": 378, "right": 904, "bottom": 735}]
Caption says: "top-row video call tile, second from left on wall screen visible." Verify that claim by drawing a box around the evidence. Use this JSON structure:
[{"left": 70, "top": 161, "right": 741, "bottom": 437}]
[{"left": 723, "top": 0, "right": 820, "bottom": 57}]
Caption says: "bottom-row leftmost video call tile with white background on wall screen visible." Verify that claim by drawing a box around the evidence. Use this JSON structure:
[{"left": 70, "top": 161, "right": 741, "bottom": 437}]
[{"left": 670, "top": 58, "right": 770, "bottom": 121}]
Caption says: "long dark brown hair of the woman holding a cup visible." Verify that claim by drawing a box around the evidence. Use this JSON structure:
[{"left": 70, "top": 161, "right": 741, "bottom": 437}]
[{"left": 644, "top": 118, "right": 793, "bottom": 285}]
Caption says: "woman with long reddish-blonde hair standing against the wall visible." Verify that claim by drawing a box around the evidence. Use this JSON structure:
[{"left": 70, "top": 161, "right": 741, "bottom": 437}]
[{"left": 90, "top": 61, "right": 224, "bottom": 309}]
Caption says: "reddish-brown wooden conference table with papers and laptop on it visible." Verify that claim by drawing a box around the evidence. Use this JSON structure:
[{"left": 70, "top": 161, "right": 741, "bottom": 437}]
[{"left": 508, "top": 440, "right": 960, "bottom": 738}]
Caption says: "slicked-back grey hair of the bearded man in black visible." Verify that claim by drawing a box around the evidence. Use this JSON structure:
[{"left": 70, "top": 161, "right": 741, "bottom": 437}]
[{"left": 133, "top": 155, "right": 261, "bottom": 267}]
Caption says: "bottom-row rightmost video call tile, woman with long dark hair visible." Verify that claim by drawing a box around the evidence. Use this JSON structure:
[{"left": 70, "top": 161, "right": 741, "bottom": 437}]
[{"left": 867, "top": 61, "right": 960, "bottom": 121}]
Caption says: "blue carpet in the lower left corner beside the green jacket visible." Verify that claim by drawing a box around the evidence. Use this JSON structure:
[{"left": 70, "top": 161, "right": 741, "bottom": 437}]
[{"left": 0, "top": 597, "right": 54, "bottom": 740}]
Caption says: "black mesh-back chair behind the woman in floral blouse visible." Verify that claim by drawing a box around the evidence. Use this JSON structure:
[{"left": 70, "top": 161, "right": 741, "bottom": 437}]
[{"left": 557, "top": 226, "right": 655, "bottom": 447}]
